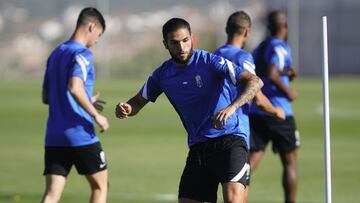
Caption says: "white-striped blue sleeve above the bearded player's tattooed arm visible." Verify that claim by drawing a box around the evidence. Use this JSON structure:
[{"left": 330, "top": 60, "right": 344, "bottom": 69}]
[{"left": 210, "top": 54, "right": 245, "bottom": 85}]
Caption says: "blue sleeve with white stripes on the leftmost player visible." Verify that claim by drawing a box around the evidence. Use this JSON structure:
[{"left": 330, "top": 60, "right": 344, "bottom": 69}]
[{"left": 70, "top": 51, "right": 93, "bottom": 82}]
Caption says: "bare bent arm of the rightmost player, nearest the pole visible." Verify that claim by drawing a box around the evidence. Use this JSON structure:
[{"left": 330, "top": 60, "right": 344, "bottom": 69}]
[{"left": 268, "top": 64, "right": 297, "bottom": 101}]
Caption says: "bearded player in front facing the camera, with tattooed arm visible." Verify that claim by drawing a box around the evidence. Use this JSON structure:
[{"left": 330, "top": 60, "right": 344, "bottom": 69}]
[{"left": 115, "top": 18, "right": 262, "bottom": 203}]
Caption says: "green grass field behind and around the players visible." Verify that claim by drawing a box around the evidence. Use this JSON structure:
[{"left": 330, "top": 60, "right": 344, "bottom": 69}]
[{"left": 0, "top": 77, "right": 360, "bottom": 203}]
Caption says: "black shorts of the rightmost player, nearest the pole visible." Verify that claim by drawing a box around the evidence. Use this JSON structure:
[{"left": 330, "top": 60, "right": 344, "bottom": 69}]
[{"left": 249, "top": 115, "right": 300, "bottom": 154}]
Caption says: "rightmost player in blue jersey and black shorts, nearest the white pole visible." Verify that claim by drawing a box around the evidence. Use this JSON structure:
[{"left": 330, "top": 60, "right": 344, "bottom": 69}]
[{"left": 250, "top": 11, "right": 300, "bottom": 203}]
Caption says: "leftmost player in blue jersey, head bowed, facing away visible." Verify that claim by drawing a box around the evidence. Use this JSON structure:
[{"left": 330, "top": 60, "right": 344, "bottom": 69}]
[{"left": 41, "top": 8, "right": 109, "bottom": 203}]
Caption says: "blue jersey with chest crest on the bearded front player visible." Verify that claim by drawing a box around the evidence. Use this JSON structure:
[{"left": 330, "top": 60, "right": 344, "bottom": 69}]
[{"left": 139, "top": 50, "right": 249, "bottom": 146}]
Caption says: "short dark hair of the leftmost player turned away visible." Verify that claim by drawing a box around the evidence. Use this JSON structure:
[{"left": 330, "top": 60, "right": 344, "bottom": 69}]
[{"left": 76, "top": 7, "right": 106, "bottom": 32}]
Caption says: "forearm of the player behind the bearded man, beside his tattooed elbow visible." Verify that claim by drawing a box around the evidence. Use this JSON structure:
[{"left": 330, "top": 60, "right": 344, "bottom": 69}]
[{"left": 254, "top": 90, "right": 286, "bottom": 120}]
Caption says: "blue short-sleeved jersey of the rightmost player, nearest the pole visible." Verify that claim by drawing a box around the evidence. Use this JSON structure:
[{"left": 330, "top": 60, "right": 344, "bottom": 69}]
[{"left": 250, "top": 37, "right": 293, "bottom": 116}]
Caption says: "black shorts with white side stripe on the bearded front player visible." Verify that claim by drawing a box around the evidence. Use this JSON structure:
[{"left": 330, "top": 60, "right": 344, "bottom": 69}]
[{"left": 179, "top": 135, "right": 250, "bottom": 202}]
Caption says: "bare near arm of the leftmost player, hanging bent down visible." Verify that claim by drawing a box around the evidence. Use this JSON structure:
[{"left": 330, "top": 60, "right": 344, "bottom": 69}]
[{"left": 68, "top": 77, "right": 109, "bottom": 132}]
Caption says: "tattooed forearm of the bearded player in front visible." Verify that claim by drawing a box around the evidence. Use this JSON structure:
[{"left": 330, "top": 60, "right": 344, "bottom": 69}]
[{"left": 233, "top": 75, "right": 262, "bottom": 108}]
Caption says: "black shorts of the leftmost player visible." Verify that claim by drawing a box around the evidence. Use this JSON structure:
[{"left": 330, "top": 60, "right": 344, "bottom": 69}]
[{"left": 43, "top": 142, "right": 107, "bottom": 177}]
